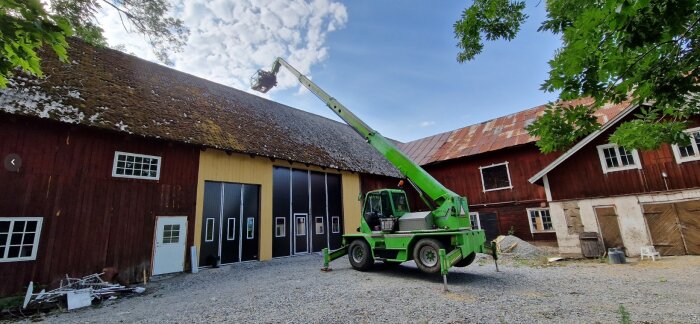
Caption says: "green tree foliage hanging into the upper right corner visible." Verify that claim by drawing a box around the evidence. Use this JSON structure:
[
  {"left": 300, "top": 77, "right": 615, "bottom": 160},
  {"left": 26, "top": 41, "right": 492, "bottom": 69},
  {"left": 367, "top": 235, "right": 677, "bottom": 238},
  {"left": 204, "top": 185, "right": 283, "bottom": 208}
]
[{"left": 455, "top": 0, "right": 700, "bottom": 152}]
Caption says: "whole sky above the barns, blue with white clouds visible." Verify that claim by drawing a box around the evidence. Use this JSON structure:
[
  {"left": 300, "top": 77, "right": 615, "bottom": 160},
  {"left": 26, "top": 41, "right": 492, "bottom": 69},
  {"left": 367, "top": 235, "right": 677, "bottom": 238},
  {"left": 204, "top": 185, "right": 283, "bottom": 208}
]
[{"left": 99, "top": 0, "right": 560, "bottom": 142}]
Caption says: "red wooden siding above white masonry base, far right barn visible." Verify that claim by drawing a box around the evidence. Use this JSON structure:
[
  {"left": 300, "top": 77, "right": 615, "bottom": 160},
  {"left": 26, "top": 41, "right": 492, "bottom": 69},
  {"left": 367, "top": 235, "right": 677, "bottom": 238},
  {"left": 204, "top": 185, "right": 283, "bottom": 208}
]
[{"left": 547, "top": 116, "right": 700, "bottom": 200}]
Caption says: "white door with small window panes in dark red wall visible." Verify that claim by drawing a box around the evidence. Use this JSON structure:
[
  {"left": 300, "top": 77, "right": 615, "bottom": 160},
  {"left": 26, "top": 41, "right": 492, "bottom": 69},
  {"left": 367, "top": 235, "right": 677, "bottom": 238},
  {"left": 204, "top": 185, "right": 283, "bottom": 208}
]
[{"left": 153, "top": 216, "right": 187, "bottom": 275}]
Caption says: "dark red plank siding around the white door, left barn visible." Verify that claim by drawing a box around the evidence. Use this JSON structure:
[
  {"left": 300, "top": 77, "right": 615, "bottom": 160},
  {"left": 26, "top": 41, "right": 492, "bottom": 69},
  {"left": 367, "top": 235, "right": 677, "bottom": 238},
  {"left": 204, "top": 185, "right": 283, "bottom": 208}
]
[{"left": 0, "top": 114, "right": 199, "bottom": 295}]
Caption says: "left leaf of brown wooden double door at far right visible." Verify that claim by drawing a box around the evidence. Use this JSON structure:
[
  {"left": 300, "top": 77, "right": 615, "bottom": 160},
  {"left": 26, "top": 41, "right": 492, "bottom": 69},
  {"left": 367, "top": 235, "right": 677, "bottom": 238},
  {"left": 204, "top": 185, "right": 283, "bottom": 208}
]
[{"left": 643, "top": 203, "right": 685, "bottom": 255}]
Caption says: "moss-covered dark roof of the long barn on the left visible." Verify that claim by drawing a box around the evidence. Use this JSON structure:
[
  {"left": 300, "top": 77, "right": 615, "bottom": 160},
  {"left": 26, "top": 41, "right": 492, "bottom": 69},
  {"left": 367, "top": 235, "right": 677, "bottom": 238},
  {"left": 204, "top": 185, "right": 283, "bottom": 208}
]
[{"left": 0, "top": 40, "right": 399, "bottom": 176}]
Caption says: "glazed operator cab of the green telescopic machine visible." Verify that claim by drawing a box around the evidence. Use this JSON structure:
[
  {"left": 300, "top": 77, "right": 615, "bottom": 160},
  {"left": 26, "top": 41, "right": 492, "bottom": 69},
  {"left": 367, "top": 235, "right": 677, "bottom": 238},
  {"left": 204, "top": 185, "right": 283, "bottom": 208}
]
[{"left": 362, "top": 189, "right": 409, "bottom": 231}]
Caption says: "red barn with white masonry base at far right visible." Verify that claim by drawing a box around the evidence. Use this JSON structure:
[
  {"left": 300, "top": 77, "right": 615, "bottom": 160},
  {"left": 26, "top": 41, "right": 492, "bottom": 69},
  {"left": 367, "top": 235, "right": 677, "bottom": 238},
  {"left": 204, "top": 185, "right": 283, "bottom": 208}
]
[{"left": 530, "top": 106, "right": 700, "bottom": 255}]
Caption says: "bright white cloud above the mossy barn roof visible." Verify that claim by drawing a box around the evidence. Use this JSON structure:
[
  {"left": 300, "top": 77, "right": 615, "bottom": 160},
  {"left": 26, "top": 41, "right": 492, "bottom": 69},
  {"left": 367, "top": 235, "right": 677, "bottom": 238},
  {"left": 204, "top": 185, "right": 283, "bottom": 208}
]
[{"left": 99, "top": 0, "right": 348, "bottom": 93}]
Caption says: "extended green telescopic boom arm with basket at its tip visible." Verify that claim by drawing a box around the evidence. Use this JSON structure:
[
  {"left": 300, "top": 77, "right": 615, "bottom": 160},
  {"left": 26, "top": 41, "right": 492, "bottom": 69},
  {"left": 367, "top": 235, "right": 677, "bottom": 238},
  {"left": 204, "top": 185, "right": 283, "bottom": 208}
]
[{"left": 253, "top": 58, "right": 467, "bottom": 221}]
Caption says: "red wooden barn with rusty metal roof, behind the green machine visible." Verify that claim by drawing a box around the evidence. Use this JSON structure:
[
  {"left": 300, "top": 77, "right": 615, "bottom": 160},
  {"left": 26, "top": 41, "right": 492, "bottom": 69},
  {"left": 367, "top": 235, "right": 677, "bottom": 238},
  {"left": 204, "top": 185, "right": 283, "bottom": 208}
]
[{"left": 363, "top": 99, "right": 625, "bottom": 243}]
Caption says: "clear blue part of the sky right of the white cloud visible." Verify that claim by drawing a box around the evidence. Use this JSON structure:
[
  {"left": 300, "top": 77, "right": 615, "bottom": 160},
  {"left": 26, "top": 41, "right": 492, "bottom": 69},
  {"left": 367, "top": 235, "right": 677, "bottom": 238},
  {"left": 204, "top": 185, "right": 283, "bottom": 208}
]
[{"left": 272, "top": 0, "right": 560, "bottom": 141}]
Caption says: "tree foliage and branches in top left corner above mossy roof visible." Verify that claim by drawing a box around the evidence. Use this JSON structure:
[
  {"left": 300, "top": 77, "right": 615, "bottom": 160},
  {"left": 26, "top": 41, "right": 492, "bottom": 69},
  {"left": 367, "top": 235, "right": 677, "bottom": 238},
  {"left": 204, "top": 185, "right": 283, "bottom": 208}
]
[{"left": 0, "top": 0, "right": 189, "bottom": 87}]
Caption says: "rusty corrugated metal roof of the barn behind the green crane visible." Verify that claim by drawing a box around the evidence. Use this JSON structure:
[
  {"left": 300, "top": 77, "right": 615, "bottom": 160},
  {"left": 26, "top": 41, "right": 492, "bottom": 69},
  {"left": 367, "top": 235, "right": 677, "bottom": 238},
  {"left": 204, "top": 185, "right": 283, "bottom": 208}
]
[{"left": 400, "top": 98, "right": 629, "bottom": 165}]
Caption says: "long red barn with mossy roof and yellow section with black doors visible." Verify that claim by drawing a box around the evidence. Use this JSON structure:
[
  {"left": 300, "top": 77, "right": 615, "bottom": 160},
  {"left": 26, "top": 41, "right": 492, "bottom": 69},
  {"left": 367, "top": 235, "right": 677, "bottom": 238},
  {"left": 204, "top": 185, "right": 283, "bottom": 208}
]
[{"left": 0, "top": 40, "right": 399, "bottom": 296}]
